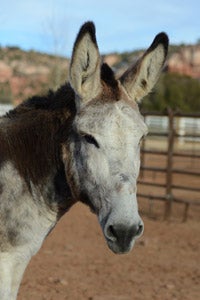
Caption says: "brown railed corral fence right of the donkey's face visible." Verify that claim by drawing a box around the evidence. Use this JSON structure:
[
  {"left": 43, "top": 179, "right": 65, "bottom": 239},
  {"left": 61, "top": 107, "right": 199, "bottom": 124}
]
[{"left": 138, "top": 109, "right": 200, "bottom": 221}]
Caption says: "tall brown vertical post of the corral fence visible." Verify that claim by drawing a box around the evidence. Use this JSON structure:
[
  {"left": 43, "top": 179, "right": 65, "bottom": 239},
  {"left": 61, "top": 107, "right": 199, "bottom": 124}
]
[{"left": 164, "top": 108, "right": 175, "bottom": 220}]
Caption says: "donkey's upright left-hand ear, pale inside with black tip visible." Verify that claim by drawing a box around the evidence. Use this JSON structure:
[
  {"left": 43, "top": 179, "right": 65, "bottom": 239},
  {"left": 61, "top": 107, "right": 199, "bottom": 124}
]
[{"left": 69, "top": 22, "right": 101, "bottom": 102}]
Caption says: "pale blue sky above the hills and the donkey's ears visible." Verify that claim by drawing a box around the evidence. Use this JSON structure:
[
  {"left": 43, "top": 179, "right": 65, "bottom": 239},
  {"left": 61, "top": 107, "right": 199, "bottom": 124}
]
[{"left": 0, "top": 0, "right": 200, "bottom": 57}]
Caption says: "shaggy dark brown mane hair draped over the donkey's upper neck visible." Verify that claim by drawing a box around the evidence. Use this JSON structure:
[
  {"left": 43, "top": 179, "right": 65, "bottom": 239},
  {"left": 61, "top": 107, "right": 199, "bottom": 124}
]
[{"left": 0, "top": 84, "right": 76, "bottom": 183}]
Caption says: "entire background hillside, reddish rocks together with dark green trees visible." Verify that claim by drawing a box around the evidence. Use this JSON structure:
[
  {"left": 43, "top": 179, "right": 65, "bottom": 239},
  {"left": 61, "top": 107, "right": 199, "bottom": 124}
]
[{"left": 0, "top": 44, "right": 200, "bottom": 112}]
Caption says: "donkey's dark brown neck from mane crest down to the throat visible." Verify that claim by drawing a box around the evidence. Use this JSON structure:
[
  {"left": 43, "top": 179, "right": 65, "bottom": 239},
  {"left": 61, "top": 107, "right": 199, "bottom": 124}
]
[{"left": 0, "top": 86, "right": 75, "bottom": 215}]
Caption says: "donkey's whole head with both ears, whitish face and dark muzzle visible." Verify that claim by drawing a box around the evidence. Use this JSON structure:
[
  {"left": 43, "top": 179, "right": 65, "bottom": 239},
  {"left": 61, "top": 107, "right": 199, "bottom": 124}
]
[{"left": 63, "top": 22, "right": 168, "bottom": 253}]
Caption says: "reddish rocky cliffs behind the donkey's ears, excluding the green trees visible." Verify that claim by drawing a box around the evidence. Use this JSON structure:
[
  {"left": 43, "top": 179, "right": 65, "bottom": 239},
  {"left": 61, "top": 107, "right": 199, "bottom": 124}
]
[{"left": 0, "top": 45, "right": 200, "bottom": 103}]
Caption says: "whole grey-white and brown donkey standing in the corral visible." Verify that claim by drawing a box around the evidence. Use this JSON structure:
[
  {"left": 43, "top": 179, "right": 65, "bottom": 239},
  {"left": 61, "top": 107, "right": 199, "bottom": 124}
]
[{"left": 0, "top": 22, "right": 168, "bottom": 300}]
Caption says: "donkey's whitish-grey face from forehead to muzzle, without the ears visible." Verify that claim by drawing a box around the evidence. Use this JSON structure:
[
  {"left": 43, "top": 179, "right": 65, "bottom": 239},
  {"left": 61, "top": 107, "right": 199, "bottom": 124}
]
[{"left": 72, "top": 100, "right": 147, "bottom": 253}]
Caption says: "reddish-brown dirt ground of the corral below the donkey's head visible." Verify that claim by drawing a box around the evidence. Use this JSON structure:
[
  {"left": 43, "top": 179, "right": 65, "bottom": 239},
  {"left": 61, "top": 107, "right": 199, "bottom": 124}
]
[{"left": 18, "top": 199, "right": 200, "bottom": 300}]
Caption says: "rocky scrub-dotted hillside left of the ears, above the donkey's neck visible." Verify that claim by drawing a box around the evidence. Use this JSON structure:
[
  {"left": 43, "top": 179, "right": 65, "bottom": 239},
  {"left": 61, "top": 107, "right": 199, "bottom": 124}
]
[{"left": 0, "top": 47, "right": 68, "bottom": 104}]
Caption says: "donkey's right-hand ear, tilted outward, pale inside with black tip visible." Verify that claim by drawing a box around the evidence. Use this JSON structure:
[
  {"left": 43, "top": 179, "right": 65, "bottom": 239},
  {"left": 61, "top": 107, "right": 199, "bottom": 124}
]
[{"left": 120, "top": 32, "right": 169, "bottom": 101}]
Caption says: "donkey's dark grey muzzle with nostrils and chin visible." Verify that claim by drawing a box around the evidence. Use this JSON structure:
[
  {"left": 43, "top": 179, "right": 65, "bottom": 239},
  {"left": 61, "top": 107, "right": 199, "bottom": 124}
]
[{"left": 105, "top": 221, "right": 144, "bottom": 253}]
